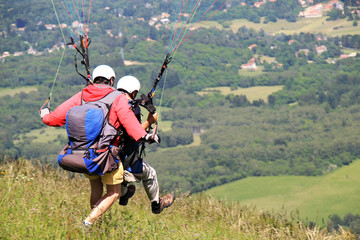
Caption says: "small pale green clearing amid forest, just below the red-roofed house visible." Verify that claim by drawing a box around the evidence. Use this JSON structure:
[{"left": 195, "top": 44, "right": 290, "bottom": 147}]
[{"left": 197, "top": 86, "right": 283, "bottom": 102}]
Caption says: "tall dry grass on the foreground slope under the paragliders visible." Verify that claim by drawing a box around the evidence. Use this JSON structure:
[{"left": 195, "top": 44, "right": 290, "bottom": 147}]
[{"left": 0, "top": 160, "right": 354, "bottom": 240}]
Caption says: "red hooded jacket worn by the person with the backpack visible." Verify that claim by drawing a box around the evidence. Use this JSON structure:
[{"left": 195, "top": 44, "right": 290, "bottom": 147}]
[{"left": 42, "top": 84, "right": 146, "bottom": 141}]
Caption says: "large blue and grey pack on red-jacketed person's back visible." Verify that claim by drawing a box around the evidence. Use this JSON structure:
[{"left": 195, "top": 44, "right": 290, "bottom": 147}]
[{"left": 58, "top": 91, "right": 122, "bottom": 175}]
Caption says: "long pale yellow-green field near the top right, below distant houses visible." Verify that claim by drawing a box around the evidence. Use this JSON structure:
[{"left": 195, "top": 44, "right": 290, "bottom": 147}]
[{"left": 202, "top": 17, "right": 360, "bottom": 36}]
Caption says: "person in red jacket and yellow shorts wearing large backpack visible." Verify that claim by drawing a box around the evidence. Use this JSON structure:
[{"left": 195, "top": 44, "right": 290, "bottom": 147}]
[{"left": 40, "top": 65, "right": 160, "bottom": 226}]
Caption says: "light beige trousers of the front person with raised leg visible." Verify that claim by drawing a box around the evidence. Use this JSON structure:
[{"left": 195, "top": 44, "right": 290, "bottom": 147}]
[{"left": 121, "top": 160, "right": 159, "bottom": 202}]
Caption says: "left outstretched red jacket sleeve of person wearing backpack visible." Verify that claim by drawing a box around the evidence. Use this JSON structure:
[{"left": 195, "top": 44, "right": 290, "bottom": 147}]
[{"left": 42, "top": 92, "right": 81, "bottom": 127}]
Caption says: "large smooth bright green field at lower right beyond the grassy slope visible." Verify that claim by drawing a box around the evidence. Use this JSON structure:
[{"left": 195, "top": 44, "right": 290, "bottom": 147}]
[{"left": 206, "top": 160, "right": 360, "bottom": 225}]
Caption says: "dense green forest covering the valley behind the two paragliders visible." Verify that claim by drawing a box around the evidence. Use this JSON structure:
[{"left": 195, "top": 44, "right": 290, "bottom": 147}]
[{"left": 0, "top": 0, "right": 360, "bottom": 193}]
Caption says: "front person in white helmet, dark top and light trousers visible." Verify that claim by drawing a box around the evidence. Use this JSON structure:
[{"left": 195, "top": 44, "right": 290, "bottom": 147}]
[{"left": 116, "top": 76, "right": 175, "bottom": 214}]
